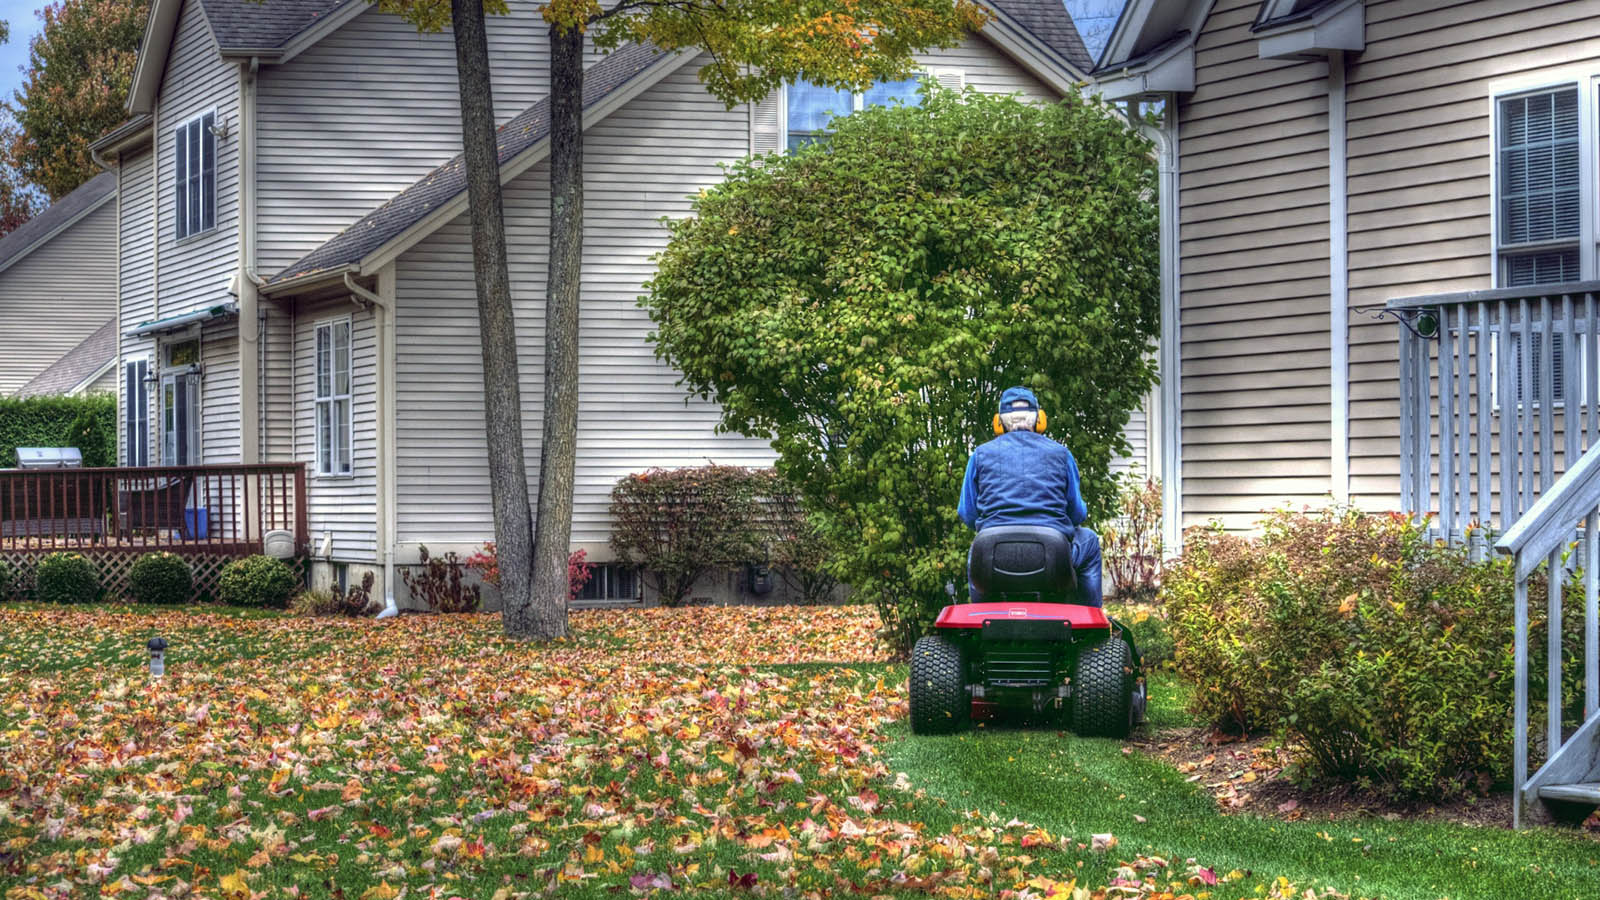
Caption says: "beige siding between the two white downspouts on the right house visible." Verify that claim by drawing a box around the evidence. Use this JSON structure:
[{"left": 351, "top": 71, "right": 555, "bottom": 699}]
[{"left": 1179, "top": 0, "right": 1331, "bottom": 528}]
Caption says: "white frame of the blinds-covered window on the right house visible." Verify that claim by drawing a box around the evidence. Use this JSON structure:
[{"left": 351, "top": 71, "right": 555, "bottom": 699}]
[{"left": 1488, "top": 66, "right": 1600, "bottom": 287}]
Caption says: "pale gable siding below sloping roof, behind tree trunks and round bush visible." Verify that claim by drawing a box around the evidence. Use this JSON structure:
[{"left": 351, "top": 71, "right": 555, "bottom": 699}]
[{"left": 395, "top": 38, "right": 1075, "bottom": 547}]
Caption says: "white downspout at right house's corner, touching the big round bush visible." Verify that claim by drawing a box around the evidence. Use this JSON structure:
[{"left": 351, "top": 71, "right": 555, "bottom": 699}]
[{"left": 1130, "top": 101, "right": 1184, "bottom": 557}]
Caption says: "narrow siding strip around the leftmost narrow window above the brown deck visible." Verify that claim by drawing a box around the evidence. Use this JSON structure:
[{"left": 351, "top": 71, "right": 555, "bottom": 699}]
[{"left": 114, "top": 151, "right": 160, "bottom": 464}]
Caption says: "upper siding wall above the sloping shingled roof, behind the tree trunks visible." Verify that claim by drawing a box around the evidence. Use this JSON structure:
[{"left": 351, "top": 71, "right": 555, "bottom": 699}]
[{"left": 256, "top": 0, "right": 563, "bottom": 275}]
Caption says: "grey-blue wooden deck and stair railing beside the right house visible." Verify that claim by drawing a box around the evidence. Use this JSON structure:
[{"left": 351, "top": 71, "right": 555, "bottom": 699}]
[{"left": 1389, "top": 282, "right": 1600, "bottom": 826}]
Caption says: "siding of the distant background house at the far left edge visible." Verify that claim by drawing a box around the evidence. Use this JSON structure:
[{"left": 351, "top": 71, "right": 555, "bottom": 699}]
[{"left": 0, "top": 197, "right": 117, "bottom": 397}]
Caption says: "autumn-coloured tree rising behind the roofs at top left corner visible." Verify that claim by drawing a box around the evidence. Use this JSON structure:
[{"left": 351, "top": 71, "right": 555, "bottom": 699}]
[{"left": 0, "top": 0, "right": 149, "bottom": 200}]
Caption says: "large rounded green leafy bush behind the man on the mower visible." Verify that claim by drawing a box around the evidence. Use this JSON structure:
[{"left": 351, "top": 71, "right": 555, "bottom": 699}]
[{"left": 642, "top": 85, "right": 1160, "bottom": 650}]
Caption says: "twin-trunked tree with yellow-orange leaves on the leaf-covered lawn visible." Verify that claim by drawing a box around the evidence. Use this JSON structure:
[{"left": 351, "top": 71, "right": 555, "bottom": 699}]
[{"left": 384, "top": 0, "right": 989, "bottom": 639}]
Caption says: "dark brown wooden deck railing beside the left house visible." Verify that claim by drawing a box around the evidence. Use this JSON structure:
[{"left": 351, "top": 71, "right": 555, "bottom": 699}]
[{"left": 0, "top": 463, "right": 309, "bottom": 554}]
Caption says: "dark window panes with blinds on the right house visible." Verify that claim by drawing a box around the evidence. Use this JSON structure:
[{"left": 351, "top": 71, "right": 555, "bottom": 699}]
[{"left": 1494, "top": 85, "right": 1582, "bottom": 287}]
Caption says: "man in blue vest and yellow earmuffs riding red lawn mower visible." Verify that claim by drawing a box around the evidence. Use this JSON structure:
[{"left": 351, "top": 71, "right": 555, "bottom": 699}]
[{"left": 910, "top": 388, "right": 1146, "bottom": 738}]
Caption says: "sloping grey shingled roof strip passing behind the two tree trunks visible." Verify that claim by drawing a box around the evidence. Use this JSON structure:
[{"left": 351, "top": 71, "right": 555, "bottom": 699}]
[{"left": 267, "top": 45, "right": 685, "bottom": 290}]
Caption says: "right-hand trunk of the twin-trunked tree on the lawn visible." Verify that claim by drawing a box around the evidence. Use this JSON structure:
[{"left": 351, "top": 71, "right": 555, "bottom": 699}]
[{"left": 533, "top": 27, "right": 584, "bottom": 637}]
